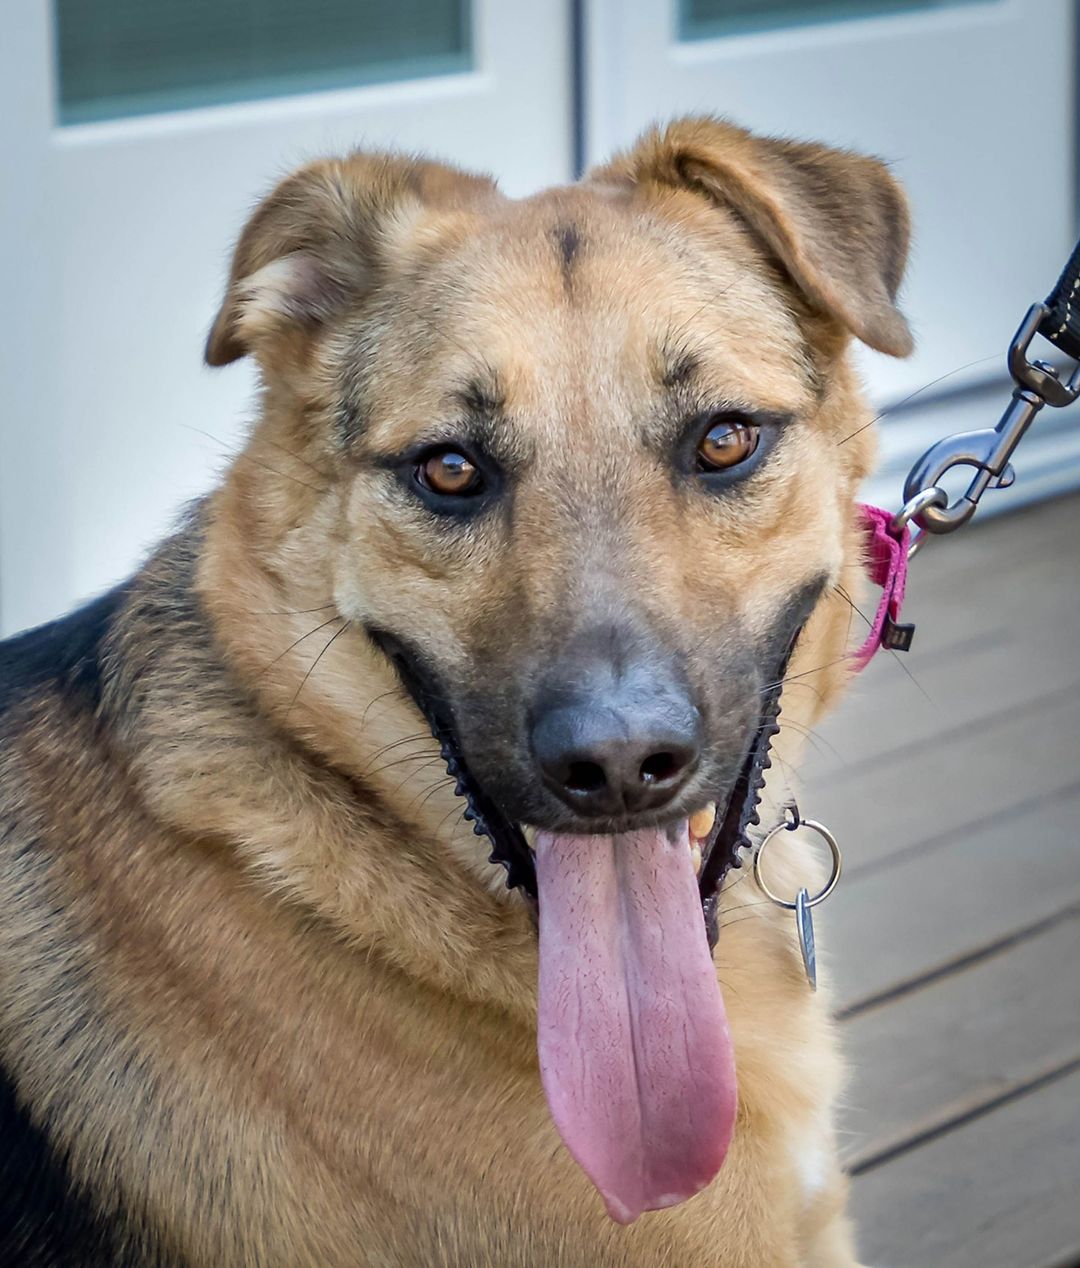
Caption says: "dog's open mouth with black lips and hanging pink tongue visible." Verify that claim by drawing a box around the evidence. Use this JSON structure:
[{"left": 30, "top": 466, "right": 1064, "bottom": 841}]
[{"left": 371, "top": 630, "right": 794, "bottom": 1224}]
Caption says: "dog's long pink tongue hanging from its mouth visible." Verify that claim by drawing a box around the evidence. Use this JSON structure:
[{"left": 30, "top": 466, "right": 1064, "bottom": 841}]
[{"left": 536, "top": 828, "right": 735, "bottom": 1224}]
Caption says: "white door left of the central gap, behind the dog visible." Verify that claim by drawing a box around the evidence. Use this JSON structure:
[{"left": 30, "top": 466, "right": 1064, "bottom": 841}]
[{"left": 0, "top": 0, "right": 573, "bottom": 631}]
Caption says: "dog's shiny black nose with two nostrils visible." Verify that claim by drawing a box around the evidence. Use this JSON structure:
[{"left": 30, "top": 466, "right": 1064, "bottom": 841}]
[{"left": 531, "top": 661, "right": 701, "bottom": 818}]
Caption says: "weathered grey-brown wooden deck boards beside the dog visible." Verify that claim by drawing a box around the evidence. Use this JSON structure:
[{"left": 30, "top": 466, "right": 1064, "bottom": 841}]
[{"left": 802, "top": 496, "right": 1080, "bottom": 1268}]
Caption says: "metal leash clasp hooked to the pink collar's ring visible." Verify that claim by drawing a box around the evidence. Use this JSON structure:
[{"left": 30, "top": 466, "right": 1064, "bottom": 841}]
[{"left": 895, "top": 304, "right": 1080, "bottom": 554}]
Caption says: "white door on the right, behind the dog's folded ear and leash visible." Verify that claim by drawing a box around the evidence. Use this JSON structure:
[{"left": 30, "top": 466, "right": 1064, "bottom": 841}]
[{"left": 584, "top": 0, "right": 1080, "bottom": 506}]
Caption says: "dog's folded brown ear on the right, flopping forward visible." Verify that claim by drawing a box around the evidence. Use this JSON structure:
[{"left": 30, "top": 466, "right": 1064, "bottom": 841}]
[{"left": 591, "top": 118, "right": 913, "bottom": 356}]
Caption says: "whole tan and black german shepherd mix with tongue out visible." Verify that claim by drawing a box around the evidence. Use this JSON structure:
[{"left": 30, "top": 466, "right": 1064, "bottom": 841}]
[{"left": 0, "top": 119, "right": 910, "bottom": 1268}]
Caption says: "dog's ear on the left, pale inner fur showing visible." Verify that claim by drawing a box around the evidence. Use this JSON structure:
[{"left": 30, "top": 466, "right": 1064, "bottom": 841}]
[{"left": 205, "top": 153, "right": 496, "bottom": 365}]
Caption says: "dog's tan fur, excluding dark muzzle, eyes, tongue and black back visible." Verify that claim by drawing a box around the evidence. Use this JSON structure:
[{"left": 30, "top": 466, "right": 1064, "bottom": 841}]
[{"left": 0, "top": 120, "right": 909, "bottom": 1268}]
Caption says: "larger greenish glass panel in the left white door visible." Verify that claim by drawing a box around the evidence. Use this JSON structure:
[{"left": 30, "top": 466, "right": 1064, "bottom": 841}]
[{"left": 56, "top": 0, "right": 472, "bottom": 123}]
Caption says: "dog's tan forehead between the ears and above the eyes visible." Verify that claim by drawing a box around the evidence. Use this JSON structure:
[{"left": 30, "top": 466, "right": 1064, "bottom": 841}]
[{"left": 349, "top": 186, "right": 816, "bottom": 445}]
